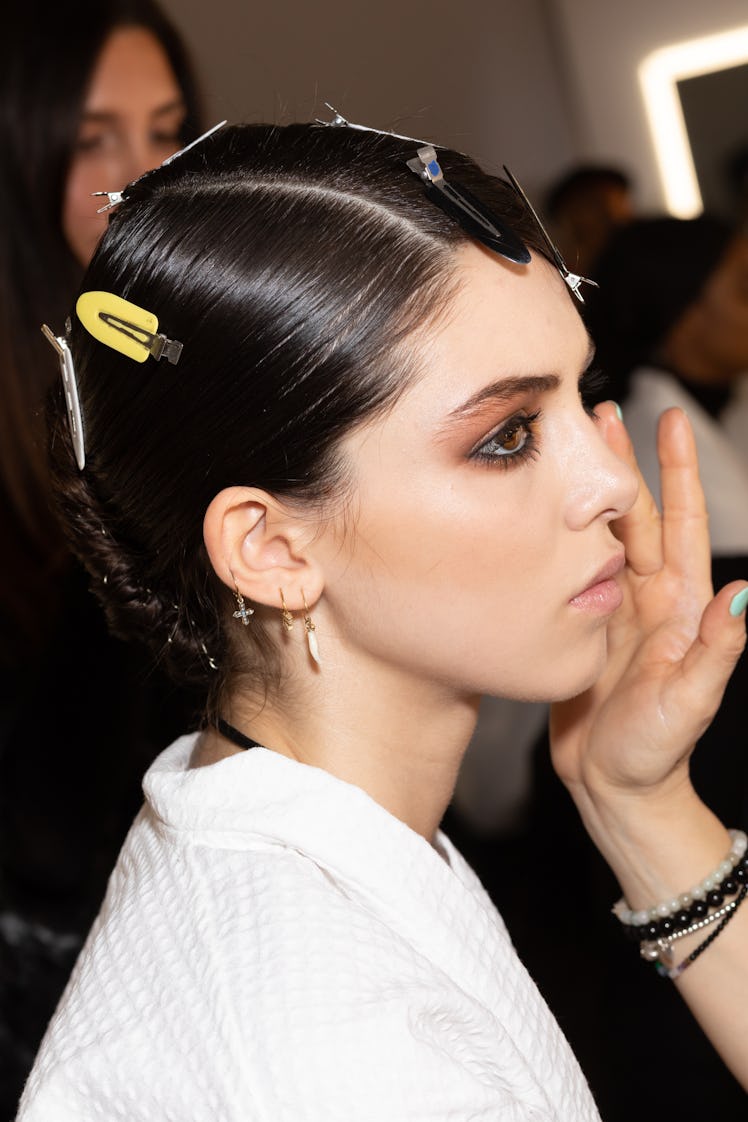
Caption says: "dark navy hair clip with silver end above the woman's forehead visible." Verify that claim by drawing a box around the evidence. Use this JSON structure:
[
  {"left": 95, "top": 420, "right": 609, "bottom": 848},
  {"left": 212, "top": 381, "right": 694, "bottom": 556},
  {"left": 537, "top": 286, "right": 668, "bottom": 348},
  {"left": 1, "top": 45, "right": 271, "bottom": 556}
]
[{"left": 406, "top": 145, "right": 530, "bottom": 265}]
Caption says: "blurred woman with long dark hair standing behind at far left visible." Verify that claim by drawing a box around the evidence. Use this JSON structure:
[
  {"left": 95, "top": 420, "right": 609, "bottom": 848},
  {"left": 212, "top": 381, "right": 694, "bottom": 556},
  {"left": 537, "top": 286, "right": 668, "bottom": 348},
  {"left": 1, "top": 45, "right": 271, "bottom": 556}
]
[{"left": 0, "top": 0, "right": 205, "bottom": 1104}]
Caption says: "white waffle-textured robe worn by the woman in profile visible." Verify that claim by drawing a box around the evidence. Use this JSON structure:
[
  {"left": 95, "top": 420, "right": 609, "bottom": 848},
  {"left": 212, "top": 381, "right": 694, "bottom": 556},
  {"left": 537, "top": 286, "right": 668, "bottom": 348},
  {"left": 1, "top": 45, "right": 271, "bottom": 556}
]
[{"left": 18, "top": 736, "right": 598, "bottom": 1122}]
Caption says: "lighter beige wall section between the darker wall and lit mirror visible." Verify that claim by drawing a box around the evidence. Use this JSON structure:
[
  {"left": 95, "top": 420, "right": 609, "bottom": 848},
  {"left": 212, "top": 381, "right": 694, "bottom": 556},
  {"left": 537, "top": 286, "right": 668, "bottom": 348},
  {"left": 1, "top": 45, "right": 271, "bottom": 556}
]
[{"left": 547, "top": 0, "right": 748, "bottom": 209}]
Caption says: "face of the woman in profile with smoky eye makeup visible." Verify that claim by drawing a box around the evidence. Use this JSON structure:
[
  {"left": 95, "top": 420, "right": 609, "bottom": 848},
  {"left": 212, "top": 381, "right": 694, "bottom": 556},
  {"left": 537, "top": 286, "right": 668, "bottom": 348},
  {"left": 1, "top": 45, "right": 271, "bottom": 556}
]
[{"left": 325, "top": 246, "right": 636, "bottom": 699}]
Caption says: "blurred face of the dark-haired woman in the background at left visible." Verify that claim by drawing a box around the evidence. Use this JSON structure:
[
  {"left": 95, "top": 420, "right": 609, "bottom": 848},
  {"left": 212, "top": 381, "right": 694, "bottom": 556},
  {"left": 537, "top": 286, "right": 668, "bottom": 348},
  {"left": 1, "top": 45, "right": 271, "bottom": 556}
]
[{"left": 63, "top": 27, "right": 185, "bottom": 266}]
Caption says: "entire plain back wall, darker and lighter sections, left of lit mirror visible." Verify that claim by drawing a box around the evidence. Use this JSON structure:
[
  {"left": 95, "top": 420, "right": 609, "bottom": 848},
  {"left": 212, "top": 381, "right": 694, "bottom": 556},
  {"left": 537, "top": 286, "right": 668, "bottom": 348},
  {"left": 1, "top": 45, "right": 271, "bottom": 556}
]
[{"left": 164, "top": 0, "right": 748, "bottom": 208}]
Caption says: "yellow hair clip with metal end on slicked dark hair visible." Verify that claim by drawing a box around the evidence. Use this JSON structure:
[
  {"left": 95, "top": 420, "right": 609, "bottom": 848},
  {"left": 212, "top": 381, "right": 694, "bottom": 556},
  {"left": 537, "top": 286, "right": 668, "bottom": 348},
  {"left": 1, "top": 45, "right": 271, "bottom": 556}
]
[{"left": 75, "top": 292, "right": 182, "bottom": 364}]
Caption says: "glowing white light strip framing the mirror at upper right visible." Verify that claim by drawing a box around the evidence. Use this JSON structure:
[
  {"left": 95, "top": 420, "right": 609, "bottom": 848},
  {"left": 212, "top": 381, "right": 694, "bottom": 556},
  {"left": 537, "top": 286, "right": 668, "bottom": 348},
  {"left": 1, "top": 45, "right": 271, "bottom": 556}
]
[{"left": 639, "top": 26, "right": 748, "bottom": 218}]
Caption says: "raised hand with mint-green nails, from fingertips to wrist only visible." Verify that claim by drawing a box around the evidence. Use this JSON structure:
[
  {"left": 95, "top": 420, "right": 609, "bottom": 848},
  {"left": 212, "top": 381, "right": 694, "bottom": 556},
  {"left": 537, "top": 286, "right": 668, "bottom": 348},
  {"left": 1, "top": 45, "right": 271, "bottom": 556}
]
[{"left": 551, "top": 404, "right": 748, "bottom": 809}]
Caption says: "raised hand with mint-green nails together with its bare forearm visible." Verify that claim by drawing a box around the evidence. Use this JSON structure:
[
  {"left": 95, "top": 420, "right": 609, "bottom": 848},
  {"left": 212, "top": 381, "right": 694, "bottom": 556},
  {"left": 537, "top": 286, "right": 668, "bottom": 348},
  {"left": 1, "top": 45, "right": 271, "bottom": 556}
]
[{"left": 551, "top": 405, "right": 748, "bottom": 1091}]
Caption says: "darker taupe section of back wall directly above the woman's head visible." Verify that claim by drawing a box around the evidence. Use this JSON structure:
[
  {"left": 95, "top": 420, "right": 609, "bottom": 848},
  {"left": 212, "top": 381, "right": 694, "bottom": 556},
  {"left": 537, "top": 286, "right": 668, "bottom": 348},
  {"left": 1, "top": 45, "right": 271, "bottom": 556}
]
[{"left": 165, "top": 0, "right": 572, "bottom": 197}]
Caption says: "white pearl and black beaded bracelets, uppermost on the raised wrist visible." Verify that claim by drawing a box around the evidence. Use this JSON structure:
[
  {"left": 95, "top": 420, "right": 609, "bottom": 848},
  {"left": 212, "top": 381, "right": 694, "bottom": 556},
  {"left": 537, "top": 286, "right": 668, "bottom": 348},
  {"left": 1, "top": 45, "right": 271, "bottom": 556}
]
[{"left": 612, "top": 829, "right": 748, "bottom": 942}]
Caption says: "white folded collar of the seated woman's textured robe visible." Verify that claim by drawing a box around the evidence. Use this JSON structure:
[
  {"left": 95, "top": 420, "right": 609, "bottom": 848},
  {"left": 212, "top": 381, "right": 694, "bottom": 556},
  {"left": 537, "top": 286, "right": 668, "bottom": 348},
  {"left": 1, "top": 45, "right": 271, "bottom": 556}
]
[{"left": 144, "top": 734, "right": 508, "bottom": 997}]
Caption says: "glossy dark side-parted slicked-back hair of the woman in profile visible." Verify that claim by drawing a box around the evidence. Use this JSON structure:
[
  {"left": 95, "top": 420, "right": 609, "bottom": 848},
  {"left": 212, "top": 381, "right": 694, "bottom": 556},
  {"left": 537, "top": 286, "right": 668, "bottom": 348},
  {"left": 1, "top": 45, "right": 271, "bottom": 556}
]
[{"left": 52, "top": 125, "right": 556, "bottom": 700}]
